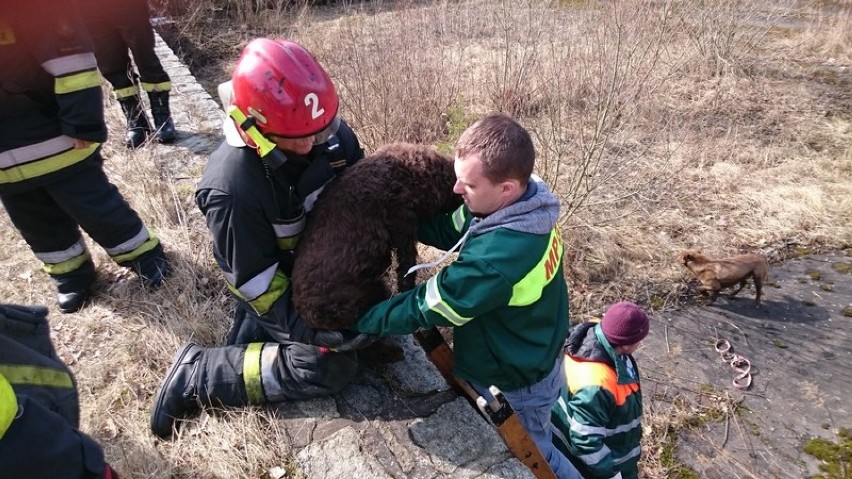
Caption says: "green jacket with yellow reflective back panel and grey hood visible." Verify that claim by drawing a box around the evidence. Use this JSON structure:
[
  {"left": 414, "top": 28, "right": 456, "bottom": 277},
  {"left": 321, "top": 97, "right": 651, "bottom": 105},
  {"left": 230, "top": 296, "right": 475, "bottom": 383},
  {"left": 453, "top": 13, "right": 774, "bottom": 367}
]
[{"left": 355, "top": 177, "right": 569, "bottom": 391}]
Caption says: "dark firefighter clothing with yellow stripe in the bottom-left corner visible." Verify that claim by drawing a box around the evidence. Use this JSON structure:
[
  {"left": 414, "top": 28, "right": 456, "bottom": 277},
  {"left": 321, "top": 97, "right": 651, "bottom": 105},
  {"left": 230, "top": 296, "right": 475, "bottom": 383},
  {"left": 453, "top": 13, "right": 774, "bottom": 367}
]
[{"left": 0, "top": 305, "right": 112, "bottom": 479}]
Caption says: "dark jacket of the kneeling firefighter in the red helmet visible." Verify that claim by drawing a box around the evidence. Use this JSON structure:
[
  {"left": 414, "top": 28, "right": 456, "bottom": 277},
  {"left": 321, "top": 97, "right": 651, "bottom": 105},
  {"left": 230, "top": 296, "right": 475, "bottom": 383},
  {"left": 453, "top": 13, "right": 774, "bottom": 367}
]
[{"left": 195, "top": 121, "right": 364, "bottom": 324}]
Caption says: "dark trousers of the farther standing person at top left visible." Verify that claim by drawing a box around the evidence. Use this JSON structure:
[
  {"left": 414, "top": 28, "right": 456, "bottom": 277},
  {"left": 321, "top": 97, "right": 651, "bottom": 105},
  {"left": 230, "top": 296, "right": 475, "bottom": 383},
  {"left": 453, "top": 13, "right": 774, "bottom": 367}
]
[{"left": 82, "top": 0, "right": 169, "bottom": 90}]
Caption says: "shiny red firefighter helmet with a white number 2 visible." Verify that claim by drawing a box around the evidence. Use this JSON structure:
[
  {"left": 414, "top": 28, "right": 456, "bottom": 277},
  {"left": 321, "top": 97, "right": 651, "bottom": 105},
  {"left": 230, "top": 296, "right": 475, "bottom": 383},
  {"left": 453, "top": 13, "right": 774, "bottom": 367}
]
[{"left": 232, "top": 38, "right": 339, "bottom": 138}]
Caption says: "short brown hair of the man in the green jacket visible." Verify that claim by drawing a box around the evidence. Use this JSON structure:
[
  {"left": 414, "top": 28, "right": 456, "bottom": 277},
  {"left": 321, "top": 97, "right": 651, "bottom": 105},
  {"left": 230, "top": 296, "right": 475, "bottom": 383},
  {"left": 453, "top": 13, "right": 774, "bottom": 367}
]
[{"left": 455, "top": 113, "right": 535, "bottom": 186}]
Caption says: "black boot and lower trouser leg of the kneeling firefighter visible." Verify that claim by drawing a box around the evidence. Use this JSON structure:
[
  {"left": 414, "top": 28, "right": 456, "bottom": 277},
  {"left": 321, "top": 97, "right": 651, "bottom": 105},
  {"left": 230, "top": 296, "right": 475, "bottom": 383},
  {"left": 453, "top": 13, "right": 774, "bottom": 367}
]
[{"left": 151, "top": 343, "right": 249, "bottom": 439}]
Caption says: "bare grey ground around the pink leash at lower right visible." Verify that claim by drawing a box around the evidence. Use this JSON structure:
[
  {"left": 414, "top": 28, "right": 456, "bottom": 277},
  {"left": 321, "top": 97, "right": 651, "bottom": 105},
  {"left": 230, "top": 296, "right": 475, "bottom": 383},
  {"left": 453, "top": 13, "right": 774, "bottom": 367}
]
[{"left": 637, "top": 250, "right": 852, "bottom": 479}]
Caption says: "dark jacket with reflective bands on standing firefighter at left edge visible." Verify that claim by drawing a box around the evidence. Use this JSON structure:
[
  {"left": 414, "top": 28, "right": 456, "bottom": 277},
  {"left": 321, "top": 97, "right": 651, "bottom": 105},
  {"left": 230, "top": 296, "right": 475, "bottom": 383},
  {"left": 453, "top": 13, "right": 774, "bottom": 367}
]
[{"left": 0, "top": 0, "right": 107, "bottom": 191}]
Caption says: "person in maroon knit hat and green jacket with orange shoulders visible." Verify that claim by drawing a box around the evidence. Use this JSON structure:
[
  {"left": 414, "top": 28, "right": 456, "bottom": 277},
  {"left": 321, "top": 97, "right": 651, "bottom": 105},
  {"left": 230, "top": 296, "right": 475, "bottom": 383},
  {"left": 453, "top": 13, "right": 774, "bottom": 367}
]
[{"left": 551, "top": 301, "right": 650, "bottom": 479}]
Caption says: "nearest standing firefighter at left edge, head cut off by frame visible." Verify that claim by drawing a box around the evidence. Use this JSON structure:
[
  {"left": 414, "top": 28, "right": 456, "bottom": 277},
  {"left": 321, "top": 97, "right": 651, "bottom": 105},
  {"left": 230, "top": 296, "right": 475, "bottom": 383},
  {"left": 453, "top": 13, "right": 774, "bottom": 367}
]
[{"left": 0, "top": 0, "right": 170, "bottom": 313}]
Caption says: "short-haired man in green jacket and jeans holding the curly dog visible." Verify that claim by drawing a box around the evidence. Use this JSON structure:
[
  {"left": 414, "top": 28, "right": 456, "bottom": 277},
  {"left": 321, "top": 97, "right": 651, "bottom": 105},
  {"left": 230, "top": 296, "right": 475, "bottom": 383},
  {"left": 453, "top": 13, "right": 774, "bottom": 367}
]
[{"left": 355, "top": 114, "right": 580, "bottom": 478}]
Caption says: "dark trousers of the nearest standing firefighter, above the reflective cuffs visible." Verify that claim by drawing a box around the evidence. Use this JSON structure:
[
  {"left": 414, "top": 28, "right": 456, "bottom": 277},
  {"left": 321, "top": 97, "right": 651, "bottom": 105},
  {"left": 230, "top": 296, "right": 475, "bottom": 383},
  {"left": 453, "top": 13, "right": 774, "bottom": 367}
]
[{"left": 0, "top": 152, "right": 144, "bottom": 282}]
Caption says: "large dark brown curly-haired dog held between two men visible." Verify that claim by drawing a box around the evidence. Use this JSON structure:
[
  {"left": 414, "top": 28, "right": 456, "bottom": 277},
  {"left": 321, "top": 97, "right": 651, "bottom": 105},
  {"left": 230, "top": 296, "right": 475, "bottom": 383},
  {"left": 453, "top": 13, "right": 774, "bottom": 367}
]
[{"left": 292, "top": 143, "right": 461, "bottom": 329}]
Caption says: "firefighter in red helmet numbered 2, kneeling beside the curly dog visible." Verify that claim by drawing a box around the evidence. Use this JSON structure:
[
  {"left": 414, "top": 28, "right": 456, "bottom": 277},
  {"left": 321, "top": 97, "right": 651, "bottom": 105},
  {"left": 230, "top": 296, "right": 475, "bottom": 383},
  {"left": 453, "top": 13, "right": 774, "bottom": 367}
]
[{"left": 151, "top": 38, "right": 374, "bottom": 438}]
